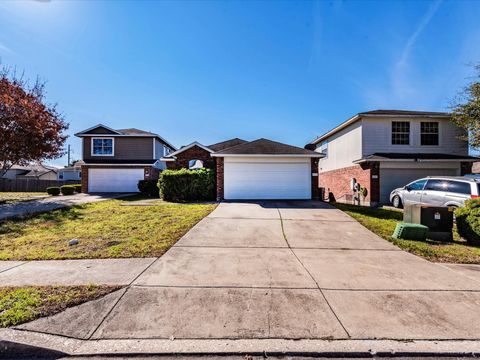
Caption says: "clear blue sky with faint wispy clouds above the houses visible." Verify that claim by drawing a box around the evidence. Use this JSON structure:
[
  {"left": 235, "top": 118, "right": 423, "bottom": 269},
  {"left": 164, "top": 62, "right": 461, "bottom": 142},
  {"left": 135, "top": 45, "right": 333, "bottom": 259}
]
[{"left": 0, "top": 1, "right": 480, "bottom": 165}]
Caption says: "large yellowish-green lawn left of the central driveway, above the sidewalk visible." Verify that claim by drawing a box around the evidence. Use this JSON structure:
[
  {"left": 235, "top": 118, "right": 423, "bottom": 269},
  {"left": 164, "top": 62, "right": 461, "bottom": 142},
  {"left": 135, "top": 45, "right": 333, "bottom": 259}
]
[{"left": 0, "top": 197, "right": 216, "bottom": 260}]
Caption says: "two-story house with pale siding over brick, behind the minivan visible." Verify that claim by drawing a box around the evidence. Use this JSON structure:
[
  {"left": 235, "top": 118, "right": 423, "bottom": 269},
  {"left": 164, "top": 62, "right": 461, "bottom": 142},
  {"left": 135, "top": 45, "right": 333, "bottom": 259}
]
[{"left": 305, "top": 110, "right": 478, "bottom": 206}]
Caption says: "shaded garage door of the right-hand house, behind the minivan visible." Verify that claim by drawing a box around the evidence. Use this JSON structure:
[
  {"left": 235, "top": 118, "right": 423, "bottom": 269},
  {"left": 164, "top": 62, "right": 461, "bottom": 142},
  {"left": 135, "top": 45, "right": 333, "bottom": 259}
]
[{"left": 380, "top": 169, "right": 458, "bottom": 204}]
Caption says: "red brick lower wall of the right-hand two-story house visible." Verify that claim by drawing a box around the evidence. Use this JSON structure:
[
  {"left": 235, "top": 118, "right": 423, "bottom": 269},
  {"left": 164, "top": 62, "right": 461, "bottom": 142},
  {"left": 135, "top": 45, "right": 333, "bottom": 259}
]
[{"left": 319, "top": 162, "right": 380, "bottom": 206}]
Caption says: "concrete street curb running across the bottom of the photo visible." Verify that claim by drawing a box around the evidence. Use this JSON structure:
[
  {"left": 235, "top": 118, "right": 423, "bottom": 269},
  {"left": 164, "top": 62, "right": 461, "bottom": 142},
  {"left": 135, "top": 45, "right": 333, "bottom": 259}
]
[{"left": 0, "top": 329, "right": 480, "bottom": 359}]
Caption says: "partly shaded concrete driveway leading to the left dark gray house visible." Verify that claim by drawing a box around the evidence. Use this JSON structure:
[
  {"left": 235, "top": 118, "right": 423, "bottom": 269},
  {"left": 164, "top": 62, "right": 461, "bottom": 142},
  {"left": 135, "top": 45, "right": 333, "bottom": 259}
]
[{"left": 0, "top": 193, "right": 132, "bottom": 221}]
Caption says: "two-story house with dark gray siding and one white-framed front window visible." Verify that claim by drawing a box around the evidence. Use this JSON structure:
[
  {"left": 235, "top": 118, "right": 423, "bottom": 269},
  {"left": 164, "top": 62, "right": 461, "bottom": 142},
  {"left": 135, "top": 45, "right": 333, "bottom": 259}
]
[{"left": 75, "top": 124, "right": 176, "bottom": 192}]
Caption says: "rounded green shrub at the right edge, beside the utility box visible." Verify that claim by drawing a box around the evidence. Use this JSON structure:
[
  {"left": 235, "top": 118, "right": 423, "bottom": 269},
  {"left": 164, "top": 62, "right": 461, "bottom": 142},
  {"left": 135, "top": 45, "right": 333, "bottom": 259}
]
[{"left": 455, "top": 199, "right": 480, "bottom": 245}]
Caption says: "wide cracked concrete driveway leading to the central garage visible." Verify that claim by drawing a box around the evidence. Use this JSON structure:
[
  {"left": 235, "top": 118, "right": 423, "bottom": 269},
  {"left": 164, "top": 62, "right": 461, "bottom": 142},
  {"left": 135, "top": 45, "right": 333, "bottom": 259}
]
[{"left": 12, "top": 202, "right": 480, "bottom": 344}]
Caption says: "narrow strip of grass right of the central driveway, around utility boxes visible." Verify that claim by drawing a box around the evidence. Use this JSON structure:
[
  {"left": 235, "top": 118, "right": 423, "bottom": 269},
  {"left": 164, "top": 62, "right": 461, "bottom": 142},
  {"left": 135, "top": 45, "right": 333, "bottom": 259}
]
[{"left": 334, "top": 203, "right": 480, "bottom": 264}]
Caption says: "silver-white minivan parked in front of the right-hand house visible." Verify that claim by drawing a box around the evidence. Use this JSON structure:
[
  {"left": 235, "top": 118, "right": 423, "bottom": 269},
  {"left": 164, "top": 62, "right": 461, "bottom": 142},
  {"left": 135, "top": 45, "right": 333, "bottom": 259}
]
[{"left": 390, "top": 176, "right": 480, "bottom": 208}]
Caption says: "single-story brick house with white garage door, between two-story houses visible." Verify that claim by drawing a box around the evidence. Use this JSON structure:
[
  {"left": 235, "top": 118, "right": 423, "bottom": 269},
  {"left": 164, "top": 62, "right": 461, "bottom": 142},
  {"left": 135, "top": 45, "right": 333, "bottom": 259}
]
[{"left": 161, "top": 139, "right": 324, "bottom": 200}]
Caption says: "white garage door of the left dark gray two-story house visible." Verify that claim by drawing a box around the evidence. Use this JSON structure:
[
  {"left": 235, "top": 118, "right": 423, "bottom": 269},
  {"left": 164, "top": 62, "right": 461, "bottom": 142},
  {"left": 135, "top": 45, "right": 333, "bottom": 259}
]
[{"left": 88, "top": 168, "right": 144, "bottom": 192}]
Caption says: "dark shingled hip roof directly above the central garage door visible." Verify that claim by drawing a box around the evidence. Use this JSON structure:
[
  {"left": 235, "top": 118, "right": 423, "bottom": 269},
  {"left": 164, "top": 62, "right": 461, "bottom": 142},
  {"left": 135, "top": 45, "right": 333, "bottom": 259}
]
[{"left": 212, "top": 139, "right": 324, "bottom": 157}]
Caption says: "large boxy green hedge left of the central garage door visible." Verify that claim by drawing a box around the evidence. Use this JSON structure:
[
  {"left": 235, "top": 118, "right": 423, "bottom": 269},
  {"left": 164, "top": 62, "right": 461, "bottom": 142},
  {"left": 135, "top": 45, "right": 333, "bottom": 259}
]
[{"left": 158, "top": 168, "right": 215, "bottom": 201}]
